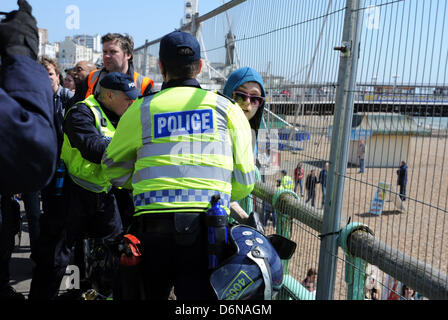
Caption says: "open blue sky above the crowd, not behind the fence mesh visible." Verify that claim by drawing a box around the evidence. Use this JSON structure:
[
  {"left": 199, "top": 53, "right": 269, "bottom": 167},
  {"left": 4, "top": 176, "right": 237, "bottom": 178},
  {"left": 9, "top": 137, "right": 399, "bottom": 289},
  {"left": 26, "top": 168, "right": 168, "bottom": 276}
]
[{"left": 0, "top": 0, "right": 228, "bottom": 47}]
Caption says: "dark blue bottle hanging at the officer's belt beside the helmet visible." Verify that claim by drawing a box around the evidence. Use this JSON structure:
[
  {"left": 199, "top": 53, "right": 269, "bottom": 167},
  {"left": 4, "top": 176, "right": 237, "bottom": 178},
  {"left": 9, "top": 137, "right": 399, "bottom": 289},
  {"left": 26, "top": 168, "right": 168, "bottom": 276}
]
[{"left": 207, "top": 194, "right": 228, "bottom": 269}]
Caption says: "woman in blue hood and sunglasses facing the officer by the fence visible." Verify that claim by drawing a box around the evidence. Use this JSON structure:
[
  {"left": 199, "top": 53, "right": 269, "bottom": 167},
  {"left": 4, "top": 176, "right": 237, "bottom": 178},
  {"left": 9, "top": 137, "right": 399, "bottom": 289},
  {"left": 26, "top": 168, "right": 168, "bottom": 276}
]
[{"left": 223, "top": 67, "right": 266, "bottom": 228}]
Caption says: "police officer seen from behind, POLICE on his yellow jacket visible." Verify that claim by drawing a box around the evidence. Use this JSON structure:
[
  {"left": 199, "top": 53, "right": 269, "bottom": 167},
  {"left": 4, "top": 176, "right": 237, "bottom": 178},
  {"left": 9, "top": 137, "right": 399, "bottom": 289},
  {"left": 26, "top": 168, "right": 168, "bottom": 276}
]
[{"left": 103, "top": 31, "right": 255, "bottom": 300}]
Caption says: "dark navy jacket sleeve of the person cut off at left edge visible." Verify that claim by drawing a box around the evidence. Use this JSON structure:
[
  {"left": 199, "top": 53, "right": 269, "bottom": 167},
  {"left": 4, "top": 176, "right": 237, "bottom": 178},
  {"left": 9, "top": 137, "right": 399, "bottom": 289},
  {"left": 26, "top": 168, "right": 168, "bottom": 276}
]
[{"left": 0, "top": 55, "right": 57, "bottom": 193}]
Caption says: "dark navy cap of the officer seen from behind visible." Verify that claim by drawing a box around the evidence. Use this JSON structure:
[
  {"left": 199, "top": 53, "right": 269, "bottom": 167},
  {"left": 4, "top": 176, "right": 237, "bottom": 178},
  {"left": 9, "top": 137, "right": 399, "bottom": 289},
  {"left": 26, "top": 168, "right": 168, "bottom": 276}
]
[{"left": 159, "top": 30, "right": 201, "bottom": 63}]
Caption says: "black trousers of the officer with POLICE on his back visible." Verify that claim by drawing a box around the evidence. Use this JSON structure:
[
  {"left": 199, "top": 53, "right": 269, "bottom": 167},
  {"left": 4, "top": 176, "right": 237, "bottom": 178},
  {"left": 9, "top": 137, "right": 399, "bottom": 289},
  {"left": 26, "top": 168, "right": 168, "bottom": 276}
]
[{"left": 124, "top": 213, "right": 216, "bottom": 301}]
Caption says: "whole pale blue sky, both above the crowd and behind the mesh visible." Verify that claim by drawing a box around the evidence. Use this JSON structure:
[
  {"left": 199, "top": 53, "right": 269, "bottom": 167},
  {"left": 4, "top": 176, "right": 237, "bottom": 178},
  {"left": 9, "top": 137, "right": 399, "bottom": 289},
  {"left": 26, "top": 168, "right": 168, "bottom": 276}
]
[{"left": 0, "top": 0, "right": 448, "bottom": 84}]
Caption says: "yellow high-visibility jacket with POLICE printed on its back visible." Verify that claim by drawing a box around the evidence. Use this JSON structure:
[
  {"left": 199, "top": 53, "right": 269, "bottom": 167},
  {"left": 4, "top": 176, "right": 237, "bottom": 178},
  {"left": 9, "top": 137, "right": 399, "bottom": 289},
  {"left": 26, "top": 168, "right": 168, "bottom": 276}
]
[{"left": 103, "top": 87, "right": 255, "bottom": 215}]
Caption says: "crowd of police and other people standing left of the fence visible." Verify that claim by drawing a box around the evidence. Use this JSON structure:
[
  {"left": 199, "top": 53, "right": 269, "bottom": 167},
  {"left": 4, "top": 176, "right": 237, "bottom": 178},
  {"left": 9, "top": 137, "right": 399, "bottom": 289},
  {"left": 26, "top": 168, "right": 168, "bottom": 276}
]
[{"left": 0, "top": 0, "right": 266, "bottom": 300}]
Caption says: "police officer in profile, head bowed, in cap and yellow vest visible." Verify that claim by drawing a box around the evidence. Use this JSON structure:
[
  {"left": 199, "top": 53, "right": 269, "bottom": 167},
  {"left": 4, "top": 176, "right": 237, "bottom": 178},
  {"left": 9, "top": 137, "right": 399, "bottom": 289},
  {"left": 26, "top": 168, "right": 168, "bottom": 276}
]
[{"left": 30, "top": 72, "right": 139, "bottom": 299}]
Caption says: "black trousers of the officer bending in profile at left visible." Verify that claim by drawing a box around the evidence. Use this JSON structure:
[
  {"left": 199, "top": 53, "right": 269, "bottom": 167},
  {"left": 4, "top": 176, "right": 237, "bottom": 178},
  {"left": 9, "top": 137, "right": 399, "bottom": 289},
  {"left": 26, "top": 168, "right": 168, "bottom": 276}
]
[{"left": 29, "top": 177, "right": 122, "bottom": 299}]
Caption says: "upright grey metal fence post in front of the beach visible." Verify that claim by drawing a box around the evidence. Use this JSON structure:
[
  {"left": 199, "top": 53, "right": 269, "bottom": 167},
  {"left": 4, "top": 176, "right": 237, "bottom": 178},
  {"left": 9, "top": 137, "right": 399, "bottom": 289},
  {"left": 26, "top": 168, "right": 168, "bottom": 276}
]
[{"left": 316, "top": 0, "right": 363, "bottom": 300}]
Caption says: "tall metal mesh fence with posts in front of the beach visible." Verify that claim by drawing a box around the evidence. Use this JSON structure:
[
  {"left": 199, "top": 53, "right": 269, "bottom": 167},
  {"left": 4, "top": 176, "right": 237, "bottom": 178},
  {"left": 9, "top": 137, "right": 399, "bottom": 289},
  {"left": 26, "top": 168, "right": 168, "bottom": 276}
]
[{"left": 134, "top": 0, "right": 448, "bottom": 299}]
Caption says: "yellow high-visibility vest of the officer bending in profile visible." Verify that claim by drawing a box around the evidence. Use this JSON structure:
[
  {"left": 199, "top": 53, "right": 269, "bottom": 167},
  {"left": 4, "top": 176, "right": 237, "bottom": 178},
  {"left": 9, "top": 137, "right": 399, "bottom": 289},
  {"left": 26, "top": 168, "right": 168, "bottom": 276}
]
[{"left": 61, "top": 95, "right": 115, "bottom": 193}]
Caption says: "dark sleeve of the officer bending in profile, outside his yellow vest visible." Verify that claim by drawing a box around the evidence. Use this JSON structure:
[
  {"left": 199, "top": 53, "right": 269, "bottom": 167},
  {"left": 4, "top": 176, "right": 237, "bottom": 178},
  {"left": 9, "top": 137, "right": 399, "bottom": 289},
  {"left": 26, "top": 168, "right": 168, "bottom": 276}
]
[{"left": 64, "top": 96, "right": 120, "bottom": 163}]
